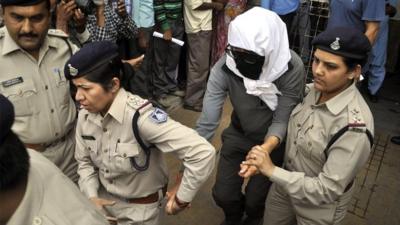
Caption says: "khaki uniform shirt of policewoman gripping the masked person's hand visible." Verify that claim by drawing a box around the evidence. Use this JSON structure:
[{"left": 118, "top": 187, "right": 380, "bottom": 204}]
[{"left": 270, "top": 84, "right": 374, "bottom": 205}]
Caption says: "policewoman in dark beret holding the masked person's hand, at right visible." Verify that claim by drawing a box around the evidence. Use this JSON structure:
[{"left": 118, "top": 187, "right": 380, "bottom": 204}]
[{"left": 242, "top": 27, "right": 374, "bottom": 225}]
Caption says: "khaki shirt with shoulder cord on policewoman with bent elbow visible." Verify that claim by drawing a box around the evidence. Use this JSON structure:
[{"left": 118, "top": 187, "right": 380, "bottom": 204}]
[{"left": 75, "top": 89, "right": 215, "bottom": 202}]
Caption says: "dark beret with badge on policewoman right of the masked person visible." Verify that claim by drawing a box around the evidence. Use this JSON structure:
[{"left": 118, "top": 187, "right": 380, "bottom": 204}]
[{"left": 312, "top": 27, "right": 371, "bottom": 59}]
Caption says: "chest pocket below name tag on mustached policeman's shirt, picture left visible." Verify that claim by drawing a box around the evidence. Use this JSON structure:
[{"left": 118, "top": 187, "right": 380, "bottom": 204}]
[{"left": 1, "top": 78, "right": 38, "bottom": 117}]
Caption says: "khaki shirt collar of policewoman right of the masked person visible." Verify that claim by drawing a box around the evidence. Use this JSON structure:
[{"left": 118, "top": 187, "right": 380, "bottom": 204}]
[{"left": 314, "top": 81, "right": 357, "bottom": 115}]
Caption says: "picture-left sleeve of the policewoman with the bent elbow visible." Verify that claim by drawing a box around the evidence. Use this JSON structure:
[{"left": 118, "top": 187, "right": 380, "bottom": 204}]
[{"left": 75, "top": 113, "right": 100, "bottom": 198}]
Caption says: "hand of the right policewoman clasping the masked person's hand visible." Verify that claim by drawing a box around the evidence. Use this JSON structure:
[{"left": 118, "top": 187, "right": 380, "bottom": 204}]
[{"left": 241, "top": 145, "right": 275, "bottom": 177}]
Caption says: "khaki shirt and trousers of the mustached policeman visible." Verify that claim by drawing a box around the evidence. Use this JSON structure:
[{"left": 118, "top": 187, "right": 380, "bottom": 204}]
[{"left": 0, "top": 27, "right": 78, "bottom": 181}]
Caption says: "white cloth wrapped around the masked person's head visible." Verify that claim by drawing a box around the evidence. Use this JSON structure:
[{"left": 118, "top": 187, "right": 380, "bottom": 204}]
[{"left": 226, "top": 7, "right": 291, "bottom": 110}]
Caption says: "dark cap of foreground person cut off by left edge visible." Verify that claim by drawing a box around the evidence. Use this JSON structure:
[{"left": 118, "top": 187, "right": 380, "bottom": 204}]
[{"left": 0, "top": 94, "right": 14, "bottom": 144}]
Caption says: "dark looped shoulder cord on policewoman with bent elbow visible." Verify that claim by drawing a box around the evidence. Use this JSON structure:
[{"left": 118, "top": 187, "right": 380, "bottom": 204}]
[{"left": 130, "top": 103, "right": 151, "bottom": 171}]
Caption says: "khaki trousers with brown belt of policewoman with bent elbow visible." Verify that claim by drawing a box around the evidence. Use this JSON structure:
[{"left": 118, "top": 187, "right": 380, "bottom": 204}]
[{"left": 99, "top": 187, "right": 165, "bottom": 225}]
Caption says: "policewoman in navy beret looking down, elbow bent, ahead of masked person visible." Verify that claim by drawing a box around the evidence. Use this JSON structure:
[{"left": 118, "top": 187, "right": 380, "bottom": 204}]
[{"left": 65, "top": 41, "right": 215, "bottom": 224}]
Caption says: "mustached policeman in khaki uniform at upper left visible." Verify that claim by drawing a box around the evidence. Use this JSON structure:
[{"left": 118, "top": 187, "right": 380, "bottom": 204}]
[{"left": 0, "top": 0, "right": 90, "bottom": 181}]
